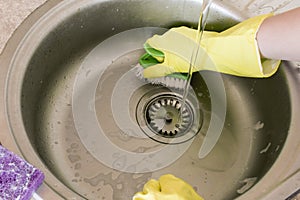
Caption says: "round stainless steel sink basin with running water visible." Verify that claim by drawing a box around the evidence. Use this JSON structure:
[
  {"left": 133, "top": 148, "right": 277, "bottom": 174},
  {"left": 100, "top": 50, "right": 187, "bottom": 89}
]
[{"left": 1, "top": 0, "right": 300, "bottom": 200}]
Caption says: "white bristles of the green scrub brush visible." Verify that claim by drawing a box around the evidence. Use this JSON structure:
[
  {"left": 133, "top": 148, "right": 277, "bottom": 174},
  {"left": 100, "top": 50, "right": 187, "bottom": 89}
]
[{"left": 134, "top": 64, "right": 186, "bottom": 90}]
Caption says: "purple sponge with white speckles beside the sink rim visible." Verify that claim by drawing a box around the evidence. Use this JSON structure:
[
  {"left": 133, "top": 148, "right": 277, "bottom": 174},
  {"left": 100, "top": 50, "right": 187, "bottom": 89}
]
[{"left": 0, "top": 145, "right": 45, "bottom": 200}]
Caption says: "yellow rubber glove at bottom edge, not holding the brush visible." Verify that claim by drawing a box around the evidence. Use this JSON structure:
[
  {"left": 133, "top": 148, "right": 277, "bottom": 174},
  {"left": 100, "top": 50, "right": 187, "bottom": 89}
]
[{"left": 132, "top": 174, "right": 203, "bottom": 200}]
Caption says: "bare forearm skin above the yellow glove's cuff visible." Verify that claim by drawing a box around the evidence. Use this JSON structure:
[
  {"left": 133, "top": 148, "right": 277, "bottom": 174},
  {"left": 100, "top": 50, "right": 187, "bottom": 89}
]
[{"left": 257, "top": 8, "right": 300, "bottom": 61}]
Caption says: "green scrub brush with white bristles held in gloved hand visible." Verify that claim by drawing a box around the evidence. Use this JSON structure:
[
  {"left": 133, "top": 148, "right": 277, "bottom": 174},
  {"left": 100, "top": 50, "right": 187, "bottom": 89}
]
[{"left": 135, "top": 43, "right": 188, "bottom": 90}]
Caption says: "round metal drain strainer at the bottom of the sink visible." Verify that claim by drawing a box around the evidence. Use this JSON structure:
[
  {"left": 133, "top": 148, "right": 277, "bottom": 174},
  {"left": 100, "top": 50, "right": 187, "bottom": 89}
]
[{"left": 136, "top": 89, "right": 202, "bottom": 144}]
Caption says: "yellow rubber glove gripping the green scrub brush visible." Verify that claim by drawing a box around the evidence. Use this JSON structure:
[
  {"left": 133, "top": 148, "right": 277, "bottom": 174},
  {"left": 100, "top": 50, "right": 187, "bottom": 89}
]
[{"left": 144, "top": 14, "right": 280, "bottom": 78}]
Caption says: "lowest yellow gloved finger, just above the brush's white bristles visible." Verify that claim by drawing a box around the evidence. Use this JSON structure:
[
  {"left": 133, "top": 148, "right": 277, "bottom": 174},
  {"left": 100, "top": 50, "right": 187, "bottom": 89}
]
[{"left": 143, "top": 63, "right": 176, "bottom": 78}]
